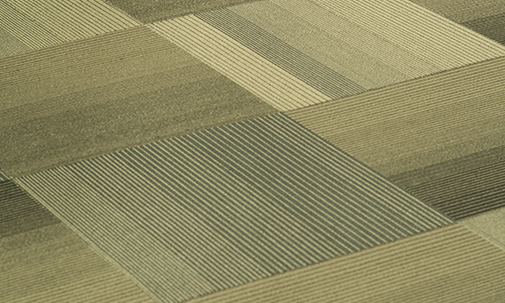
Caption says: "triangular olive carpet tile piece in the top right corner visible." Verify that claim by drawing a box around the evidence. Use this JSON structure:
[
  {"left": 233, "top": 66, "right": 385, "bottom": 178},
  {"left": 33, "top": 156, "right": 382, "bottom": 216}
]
[{"left": 411, "top": 0, "right": 505, "bottom": 44}]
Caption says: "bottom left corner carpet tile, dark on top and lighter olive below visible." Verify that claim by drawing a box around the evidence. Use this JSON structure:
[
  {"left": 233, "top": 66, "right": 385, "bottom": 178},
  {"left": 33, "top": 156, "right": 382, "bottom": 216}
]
[{"left": 0, "top": 181, "right": 153, "bottom": 303}]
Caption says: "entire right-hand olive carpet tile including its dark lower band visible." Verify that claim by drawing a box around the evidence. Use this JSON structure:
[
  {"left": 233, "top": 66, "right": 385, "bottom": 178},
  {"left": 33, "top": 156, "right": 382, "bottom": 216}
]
[{"left": 288, "top": 57, "right": 505, "bottom": 219}]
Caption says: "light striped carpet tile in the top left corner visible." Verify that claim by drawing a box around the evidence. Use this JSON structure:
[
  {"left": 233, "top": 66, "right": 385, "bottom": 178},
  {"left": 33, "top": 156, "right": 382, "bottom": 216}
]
[{"left": 0, "top": 0, "right": 139, "bottom": 57}]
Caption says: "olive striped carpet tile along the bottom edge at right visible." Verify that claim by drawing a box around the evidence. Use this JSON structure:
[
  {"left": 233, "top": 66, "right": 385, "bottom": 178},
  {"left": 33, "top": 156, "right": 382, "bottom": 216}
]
[{"left": 189, "top": 224, "right": 505, "bottom": 303}]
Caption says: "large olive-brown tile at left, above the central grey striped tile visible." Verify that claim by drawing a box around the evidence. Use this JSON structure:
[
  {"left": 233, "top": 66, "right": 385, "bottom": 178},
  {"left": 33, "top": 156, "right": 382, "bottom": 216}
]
[{"left": 0, "top": 27, "right": 276, "bottom": 177}]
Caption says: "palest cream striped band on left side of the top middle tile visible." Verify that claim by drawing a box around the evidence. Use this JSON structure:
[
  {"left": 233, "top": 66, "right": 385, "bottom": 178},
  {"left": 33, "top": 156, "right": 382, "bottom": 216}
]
[{"left": 150, "top": 15, "right": 330, "bottom": 110}]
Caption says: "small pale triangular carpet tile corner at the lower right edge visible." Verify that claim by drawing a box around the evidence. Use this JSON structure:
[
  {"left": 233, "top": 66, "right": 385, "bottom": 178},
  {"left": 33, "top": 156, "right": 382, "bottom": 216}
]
[{"left": 461, "top": 207, "right": 505, "bottom": 250}]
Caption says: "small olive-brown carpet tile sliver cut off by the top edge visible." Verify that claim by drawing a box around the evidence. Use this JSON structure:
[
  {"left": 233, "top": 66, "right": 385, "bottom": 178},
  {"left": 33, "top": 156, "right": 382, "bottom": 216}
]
[{"left": 105, "top": 0, "right": 260, "bottom": 23}]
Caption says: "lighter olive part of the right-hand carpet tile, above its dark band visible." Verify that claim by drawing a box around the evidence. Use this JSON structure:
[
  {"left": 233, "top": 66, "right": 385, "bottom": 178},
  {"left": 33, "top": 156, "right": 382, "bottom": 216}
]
[{"left": 288, "top": 57, "right": 505, "bottom": 176}]
